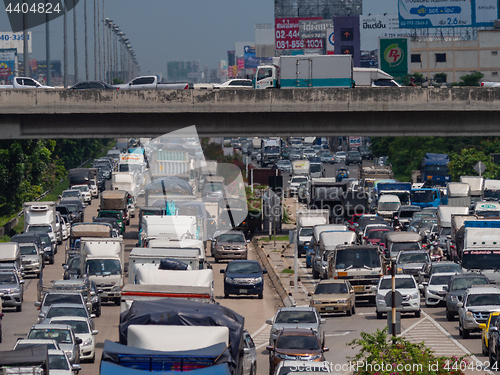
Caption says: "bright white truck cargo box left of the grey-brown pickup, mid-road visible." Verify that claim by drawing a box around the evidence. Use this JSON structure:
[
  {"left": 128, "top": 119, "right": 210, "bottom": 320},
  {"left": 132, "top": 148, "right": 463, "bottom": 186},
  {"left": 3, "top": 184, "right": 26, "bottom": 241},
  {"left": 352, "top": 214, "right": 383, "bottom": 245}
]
[{"left": 138, "top": 215, "right": 199, "bottom": 247}]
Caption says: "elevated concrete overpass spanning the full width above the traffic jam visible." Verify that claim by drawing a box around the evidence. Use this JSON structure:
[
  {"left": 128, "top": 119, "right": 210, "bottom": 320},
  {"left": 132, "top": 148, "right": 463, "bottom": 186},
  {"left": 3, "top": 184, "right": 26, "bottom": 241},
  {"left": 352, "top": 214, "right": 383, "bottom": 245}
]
[{"left": 0, "top": 87, "right": 500, "bottom": 139}]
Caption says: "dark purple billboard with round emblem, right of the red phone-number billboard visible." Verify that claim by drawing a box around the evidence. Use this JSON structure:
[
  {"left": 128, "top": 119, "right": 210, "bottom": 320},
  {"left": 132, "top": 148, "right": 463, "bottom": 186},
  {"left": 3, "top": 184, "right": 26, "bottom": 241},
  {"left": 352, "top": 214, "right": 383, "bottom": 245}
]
[{"left": 333, "top": 16, "right": 361, "bottom": 67}]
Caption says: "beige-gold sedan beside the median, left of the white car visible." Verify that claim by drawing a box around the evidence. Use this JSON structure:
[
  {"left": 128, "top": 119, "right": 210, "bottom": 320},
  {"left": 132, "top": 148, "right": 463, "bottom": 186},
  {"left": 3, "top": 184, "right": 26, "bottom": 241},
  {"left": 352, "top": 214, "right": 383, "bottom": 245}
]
[{"left": 309, "top": 279, "right": 356, "bottom": 316}]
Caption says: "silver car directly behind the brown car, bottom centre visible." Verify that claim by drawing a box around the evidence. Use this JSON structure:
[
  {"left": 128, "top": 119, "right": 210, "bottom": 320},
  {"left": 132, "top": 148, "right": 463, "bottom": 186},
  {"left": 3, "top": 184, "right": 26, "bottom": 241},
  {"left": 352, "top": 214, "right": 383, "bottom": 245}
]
[{"left": 266, "top": 306, "right": 326, "bottom": 346}]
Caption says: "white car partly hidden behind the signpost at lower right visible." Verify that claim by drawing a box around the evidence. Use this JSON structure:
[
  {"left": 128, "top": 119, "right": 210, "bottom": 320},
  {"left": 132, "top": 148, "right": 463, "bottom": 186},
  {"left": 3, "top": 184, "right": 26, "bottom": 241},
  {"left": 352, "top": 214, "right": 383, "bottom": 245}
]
[{"left": 375, "top": 274, "right": 423, "bottom": 319}]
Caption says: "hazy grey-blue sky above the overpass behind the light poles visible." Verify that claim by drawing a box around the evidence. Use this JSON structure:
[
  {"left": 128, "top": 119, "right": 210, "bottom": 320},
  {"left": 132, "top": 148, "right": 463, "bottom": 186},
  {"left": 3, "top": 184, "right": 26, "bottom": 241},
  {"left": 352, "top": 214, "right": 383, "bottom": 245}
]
[{"left": 0, "top": 0, "right": 274, "bottom": 80}]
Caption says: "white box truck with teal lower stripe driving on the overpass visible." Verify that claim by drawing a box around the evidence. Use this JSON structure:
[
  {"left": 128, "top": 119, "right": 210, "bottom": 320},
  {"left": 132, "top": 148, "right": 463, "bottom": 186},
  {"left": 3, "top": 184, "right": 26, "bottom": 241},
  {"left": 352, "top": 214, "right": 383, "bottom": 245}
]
[{"left": 254, "top": 55, "right": 353, "bottom": 89}]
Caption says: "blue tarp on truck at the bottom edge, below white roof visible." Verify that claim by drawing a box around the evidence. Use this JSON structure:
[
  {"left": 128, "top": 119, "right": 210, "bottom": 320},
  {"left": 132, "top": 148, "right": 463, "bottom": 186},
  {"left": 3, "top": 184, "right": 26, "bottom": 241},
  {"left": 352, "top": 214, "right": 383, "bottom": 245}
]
[{"left": 100, "top": 338, "right": 230, "bottom": 375}]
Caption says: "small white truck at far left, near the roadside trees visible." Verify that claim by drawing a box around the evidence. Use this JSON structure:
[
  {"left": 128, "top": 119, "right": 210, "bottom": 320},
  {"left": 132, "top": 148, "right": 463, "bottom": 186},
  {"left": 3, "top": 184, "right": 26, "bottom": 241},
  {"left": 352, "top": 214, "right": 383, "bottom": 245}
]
[{"left": 23, "top": 202, "right": 57, "bottom": 248}]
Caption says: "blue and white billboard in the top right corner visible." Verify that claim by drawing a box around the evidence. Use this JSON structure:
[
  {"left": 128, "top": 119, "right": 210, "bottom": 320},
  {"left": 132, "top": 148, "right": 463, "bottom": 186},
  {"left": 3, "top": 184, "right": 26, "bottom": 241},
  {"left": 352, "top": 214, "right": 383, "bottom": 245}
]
[{"left": 398, "top": 0, "right": 498, "bottom": 28}]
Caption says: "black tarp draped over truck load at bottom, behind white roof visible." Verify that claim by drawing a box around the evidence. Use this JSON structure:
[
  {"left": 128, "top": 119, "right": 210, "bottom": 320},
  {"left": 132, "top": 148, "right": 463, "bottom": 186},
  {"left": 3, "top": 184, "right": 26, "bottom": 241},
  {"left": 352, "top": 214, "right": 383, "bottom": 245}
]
[{"left": 118, "top": 300, "right": 245, "bottom": 375}]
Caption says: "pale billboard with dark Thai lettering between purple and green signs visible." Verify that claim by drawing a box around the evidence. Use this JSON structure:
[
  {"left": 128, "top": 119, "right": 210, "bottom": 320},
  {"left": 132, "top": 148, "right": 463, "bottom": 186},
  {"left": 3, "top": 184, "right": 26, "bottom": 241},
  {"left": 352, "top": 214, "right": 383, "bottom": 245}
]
[{"left": 359, "top": 13, "right": 410, "bottom": 51}]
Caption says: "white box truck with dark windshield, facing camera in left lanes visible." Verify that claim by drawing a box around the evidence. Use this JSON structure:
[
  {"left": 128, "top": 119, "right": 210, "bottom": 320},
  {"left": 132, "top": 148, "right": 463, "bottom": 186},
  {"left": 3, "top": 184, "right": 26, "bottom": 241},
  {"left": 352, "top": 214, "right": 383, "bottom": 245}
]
[{"left": 80, "top": 237, "right": 124, "bottom": 306}]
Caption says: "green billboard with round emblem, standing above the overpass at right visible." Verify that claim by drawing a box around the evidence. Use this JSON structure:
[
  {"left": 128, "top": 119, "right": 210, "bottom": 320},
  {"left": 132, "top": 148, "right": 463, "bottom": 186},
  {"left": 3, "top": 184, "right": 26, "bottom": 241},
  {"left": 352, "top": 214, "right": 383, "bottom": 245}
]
[{"left": 378, "top": 38, "right": 411, "bottom": 81}]
